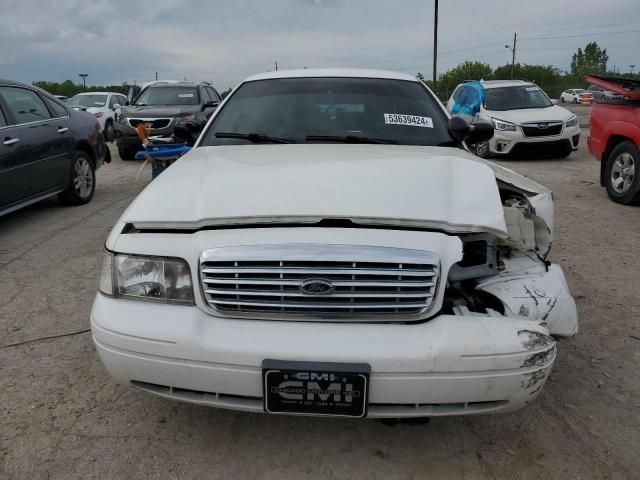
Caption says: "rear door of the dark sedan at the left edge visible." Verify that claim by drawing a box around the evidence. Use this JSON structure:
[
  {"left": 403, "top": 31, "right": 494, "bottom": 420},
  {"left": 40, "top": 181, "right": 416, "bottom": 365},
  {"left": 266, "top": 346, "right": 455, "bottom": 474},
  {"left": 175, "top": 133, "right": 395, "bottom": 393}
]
[{"left": 0, "top": 86, "right": 73, "bottom": 196}]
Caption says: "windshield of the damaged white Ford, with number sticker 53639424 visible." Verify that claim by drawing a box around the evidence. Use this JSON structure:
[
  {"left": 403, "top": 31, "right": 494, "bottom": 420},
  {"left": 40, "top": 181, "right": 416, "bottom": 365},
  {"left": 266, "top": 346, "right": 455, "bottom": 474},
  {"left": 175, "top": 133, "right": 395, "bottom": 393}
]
[{"left": 201, "top": 78, "right": 452, "bottom": 146}]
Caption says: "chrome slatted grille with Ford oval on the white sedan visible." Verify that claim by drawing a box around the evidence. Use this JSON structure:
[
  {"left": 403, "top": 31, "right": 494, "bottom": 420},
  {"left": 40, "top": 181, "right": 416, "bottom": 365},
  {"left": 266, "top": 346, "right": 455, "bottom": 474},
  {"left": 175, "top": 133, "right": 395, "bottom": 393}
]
[{"left": 200, "top": 244, "right": 440, "bottom": 321}]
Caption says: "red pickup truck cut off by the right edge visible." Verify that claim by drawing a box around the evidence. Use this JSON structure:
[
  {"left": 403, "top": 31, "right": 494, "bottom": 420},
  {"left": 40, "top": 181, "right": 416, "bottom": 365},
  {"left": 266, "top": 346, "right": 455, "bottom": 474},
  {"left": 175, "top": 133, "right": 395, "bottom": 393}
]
[{"left": 585, "top": 75, "right": 640, "bottom": 205}]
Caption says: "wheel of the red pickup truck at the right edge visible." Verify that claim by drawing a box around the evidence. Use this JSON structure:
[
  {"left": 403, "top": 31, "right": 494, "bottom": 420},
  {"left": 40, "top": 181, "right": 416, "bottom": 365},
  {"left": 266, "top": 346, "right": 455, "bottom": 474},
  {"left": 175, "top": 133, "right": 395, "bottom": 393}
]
[{"left": 604, "top": 141, "right": 640, "bottom": 205}]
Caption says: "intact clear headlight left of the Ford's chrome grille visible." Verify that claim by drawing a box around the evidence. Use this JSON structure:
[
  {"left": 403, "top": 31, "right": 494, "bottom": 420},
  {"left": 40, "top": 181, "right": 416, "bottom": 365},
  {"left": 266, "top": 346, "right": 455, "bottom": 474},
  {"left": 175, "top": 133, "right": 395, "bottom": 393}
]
[{"left": 99, "top": 252, "right": 193, "bottom": 305}]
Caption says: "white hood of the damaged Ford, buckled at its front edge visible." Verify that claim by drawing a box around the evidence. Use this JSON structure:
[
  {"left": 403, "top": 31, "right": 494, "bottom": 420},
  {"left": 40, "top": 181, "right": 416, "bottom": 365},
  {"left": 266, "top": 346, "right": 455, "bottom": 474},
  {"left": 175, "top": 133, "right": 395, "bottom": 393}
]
[{"left": 121, "top": 144, "right": 506, "bottom": 237}]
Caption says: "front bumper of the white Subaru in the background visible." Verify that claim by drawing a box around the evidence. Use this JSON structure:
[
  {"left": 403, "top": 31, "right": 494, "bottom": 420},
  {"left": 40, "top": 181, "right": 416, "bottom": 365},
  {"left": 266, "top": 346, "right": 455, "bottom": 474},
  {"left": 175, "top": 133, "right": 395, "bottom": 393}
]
[{"left": 489, "top": 126, "right": 580, "bottom": 155}]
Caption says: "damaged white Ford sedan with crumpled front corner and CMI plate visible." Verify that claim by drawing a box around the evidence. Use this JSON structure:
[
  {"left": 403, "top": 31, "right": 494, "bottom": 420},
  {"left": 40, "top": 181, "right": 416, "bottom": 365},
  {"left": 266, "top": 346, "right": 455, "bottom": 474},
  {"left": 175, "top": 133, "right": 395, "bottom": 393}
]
[{"left": 91, "top": 69, "right": 578, "bottom": 418}]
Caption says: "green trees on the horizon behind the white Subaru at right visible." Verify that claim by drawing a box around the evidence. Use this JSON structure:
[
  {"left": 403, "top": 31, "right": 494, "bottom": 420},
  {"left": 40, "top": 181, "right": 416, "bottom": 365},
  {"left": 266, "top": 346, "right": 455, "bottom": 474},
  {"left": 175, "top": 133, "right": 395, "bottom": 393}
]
[{"left": 417, "top": 42, "right": 640, "bottom": 100}]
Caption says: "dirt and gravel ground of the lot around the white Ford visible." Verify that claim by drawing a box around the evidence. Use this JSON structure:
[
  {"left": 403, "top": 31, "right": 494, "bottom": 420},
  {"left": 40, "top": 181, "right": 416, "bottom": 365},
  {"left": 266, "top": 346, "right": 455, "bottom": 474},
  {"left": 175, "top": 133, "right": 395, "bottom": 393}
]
[{"left": 0, "top": 116, "right": 640, "bottom": 480}]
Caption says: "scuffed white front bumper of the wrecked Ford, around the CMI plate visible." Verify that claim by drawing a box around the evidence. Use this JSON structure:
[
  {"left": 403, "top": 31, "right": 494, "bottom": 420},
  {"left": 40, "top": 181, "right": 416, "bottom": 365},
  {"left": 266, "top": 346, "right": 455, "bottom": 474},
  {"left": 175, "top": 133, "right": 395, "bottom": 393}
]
[{"left": 91, "top": 294, "right": 556, "bottom": 418}]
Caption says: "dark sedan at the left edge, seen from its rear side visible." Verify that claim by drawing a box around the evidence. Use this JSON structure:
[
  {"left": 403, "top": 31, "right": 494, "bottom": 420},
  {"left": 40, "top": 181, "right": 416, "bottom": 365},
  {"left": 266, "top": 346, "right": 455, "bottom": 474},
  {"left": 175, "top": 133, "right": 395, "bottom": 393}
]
[{"left": 0, "top": 80, "right": 111, "bottom": 215}]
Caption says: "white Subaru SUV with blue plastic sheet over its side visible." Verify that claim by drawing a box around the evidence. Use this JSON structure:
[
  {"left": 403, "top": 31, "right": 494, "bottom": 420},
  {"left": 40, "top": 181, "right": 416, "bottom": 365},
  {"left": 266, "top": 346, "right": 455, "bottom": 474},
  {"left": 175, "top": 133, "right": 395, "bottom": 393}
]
[{"left": 447, "top": 80, "right": 580, "bottom": 158}]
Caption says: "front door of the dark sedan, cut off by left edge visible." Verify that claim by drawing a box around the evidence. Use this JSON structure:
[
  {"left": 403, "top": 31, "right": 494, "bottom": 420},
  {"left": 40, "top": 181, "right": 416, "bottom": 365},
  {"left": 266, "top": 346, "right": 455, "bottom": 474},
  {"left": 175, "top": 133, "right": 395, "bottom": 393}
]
[{"left": 0, "top": 98, "right": 29, "bottom": 210}]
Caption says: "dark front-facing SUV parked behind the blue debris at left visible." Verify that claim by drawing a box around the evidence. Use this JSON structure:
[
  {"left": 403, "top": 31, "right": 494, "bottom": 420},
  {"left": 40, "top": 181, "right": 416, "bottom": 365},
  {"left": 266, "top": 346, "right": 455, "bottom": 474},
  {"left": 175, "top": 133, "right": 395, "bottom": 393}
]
[{"left": 116, "top": 81, "right": 222, "bottom": 160}]
